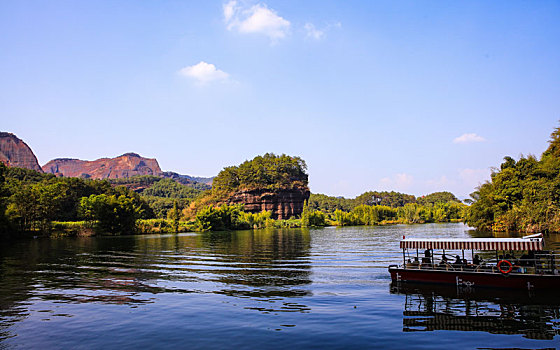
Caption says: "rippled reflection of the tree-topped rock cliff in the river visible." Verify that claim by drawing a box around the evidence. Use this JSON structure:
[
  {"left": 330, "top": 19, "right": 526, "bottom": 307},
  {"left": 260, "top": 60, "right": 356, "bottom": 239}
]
[{"left": 198, "top": 230, "right": 311, "bottom": 298}]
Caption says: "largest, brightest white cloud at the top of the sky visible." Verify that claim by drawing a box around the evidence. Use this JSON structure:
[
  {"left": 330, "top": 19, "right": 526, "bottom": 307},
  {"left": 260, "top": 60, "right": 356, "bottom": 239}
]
[{"left": 223, "top": 0, "right": 291, "bottom": 42}]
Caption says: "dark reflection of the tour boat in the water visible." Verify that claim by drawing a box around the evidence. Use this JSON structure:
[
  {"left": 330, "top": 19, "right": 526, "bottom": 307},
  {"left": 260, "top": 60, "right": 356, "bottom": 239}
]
[{"left": 391, "top": 282, "right": 560, "bottom": 339}]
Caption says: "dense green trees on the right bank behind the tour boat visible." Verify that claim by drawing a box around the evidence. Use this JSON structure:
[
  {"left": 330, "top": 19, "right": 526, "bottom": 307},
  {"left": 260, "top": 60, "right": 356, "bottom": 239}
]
[{"left": 466, "top": 128, "right": 560, "bottom": 232}]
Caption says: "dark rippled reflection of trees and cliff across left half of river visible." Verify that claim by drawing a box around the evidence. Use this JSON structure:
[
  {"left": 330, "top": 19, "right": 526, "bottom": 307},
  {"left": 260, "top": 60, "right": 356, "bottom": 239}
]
[{"left": 0, "top": 230, "right": 311, "bottom": 340}]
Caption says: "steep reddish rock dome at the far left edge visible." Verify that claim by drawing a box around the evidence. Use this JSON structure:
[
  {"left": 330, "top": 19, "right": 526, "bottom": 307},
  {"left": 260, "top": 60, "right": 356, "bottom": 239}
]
[{"left": 0, "top": 132, "right": 42, "bottom": 172}]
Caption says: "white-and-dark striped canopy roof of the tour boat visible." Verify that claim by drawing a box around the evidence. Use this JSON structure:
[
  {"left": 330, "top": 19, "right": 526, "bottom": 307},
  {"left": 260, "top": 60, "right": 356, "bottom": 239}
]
[{"left": 401, "top": 233, "right": 544, "bottom": 250}]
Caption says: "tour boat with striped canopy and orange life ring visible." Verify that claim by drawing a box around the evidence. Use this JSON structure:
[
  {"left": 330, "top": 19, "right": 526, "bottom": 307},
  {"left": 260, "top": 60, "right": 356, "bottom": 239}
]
[{"left": 389, "top": 234, "right": 560, "bottom": 290}]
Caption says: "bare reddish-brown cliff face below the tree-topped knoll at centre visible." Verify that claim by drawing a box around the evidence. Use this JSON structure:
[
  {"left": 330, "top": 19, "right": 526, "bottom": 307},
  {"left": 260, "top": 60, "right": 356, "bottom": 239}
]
[{"left": 228, "top": 188, "right": 310, "bottom": 220}]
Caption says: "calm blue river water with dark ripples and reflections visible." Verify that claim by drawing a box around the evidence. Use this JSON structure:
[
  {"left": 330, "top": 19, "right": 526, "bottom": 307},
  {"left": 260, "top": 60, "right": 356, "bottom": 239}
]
[{"left": 0, "top": 224, "right": 560, "bottom": 350}]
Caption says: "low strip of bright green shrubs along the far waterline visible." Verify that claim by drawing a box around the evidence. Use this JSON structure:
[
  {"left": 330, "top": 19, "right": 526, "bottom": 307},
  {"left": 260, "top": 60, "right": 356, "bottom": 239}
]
[{"left": 41, "top": 197, "right": 464, "bottom": 237}]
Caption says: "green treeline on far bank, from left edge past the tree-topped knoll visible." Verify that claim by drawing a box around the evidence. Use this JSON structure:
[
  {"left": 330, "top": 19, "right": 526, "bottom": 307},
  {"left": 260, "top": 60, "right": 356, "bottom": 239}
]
[{"left": 0, "top": 153, "right": 466, "bottom": 235}]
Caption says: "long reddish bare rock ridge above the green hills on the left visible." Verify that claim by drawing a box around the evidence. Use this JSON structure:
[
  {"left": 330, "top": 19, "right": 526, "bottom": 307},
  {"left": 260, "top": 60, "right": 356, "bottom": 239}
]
[{"left": 43, "top": 153, "right": 162, "bottom": 179}]
